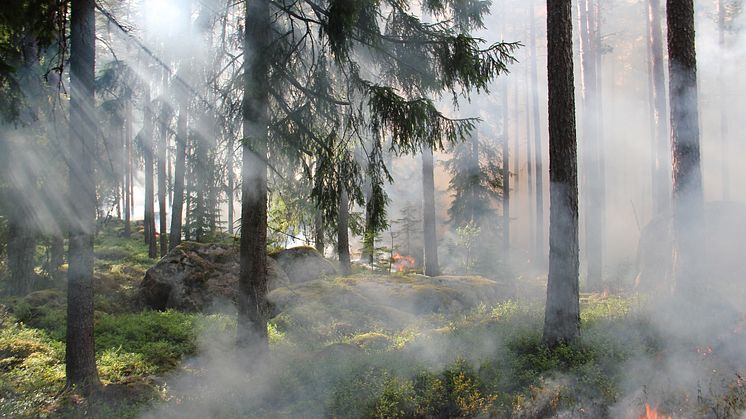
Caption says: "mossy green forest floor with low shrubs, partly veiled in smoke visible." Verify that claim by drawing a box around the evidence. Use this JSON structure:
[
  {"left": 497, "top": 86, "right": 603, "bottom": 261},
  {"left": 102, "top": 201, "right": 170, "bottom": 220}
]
[{"left": 0, "top": 226, "right": 746, "bottom": 418}]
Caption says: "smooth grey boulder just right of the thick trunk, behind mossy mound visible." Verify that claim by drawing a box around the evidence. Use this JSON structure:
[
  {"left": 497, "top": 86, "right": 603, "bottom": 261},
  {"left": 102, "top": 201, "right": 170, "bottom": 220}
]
[{"left": 270, "top": 246, "right": 337, "bottom": 284}]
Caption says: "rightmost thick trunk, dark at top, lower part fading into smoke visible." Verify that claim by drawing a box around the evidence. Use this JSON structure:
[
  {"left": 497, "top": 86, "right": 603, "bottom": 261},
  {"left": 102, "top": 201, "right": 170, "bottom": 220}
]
[{"left": 667, "top": 0, "right": 705, "bottom": 302}]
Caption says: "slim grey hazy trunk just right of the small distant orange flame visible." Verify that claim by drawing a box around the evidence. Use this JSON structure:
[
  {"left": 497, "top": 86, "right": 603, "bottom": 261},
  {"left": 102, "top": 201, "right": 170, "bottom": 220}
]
[{"left": 422, "top": 146, "right": 440, "bottom": 276}]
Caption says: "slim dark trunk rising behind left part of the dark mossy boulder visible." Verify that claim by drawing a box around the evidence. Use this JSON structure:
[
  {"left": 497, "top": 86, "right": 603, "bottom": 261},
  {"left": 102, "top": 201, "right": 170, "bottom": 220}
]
[{"left": 168, "top": 94, "right": 189, "bottom": 249}]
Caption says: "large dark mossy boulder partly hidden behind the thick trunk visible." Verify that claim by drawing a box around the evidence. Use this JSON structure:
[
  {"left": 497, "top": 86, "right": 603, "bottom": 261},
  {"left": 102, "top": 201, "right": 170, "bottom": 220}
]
[{"left": 140, "top": 242, "right": 289, "bottom": 311}]
